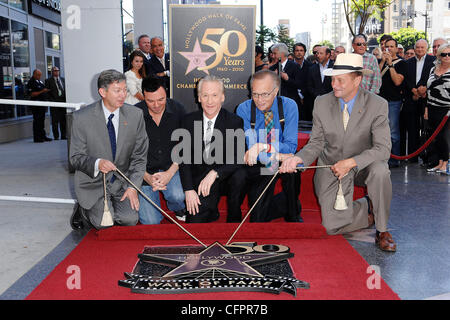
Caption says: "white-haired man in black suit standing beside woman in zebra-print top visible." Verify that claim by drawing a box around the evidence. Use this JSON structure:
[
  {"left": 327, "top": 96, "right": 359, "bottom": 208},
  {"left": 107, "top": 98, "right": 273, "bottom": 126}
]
[{"left": 400, "top": 39, "right": 436, "bottom": 162}]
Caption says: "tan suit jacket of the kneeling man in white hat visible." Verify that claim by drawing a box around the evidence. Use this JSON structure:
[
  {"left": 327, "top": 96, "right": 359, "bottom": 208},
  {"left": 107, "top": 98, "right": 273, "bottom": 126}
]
[{"left": 297, "top": 89, "right": 391, "bottom": 171}]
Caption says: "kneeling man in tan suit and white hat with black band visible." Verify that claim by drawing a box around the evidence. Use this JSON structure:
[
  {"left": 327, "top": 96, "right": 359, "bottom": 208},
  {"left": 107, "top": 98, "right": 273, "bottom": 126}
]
[{"left": 280, "top": 53, "right": 396, "bottom": 251}]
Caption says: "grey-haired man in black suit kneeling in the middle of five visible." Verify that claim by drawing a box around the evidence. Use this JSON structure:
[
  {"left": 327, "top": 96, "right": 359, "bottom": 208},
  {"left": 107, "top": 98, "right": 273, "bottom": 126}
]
[{"left": 178, "top": 76, "right": 245, "bottom": 223}]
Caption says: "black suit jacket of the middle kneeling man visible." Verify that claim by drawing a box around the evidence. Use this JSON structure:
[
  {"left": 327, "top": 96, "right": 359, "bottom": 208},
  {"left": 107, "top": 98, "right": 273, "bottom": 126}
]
[{"left": 180, "top": 108, "right": 245, "bottom": 191}]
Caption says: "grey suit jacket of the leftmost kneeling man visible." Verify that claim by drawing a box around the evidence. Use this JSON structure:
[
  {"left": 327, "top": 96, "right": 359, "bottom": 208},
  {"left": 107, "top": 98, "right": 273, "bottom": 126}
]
[{"left": 70, "top": 100, "right": 148, "bottom": 209}]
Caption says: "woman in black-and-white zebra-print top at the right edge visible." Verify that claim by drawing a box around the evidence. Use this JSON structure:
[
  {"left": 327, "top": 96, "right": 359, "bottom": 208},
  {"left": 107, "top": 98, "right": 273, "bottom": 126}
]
[{"left": 424, "top": 44, "right": 450, "bottom": 173}]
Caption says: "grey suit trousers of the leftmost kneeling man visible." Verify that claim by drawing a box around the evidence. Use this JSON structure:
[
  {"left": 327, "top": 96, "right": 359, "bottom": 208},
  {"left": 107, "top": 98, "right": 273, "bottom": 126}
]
[{"left": 85, "top": 180, "right": 139, "bottom": 230}]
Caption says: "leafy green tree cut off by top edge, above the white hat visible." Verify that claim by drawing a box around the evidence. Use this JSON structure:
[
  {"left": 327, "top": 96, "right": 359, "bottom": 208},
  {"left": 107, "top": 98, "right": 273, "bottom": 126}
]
[{"left": 342, "top": 0, "right": 393, "bottom": 36}]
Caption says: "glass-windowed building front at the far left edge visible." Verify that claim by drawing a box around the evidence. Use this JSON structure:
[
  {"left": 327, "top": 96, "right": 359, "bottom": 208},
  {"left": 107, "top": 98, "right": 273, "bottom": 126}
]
[{"left": 0, "top": 0, "right": 64, "bottom": 143}]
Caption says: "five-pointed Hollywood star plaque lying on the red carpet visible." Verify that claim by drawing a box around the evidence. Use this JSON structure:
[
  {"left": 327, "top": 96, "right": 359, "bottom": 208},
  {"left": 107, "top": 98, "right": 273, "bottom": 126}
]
[{"left": 140, "top": 242, "right": 292, "bottom": 278}]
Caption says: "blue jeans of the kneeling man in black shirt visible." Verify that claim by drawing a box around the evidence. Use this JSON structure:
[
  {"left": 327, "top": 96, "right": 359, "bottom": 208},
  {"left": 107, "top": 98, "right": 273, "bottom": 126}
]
[{"left": 139, "top": 171, "right": 186, "bottom": 224}]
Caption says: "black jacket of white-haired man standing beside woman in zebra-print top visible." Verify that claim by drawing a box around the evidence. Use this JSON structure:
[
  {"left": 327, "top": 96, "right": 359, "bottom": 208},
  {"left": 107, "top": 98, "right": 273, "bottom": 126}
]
[{"left": 404, "top": 54, "right": 436, "bottom": 103}]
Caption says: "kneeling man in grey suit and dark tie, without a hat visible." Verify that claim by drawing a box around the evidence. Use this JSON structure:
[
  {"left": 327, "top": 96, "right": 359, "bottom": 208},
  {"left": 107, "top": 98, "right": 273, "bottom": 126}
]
[{"left": 70, "top": 70, "right": 148, "bottom": 229}]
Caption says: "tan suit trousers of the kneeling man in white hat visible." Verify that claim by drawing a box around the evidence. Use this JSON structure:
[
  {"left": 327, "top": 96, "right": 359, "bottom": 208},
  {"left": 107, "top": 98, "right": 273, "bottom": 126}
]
[{"left": 314, "top": 161, "right": 392, "bottom": 235}]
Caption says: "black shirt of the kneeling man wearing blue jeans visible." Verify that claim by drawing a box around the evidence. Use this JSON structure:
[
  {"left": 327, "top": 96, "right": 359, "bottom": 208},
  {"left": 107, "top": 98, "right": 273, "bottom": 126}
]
[{"left": 138, "top": 107, "right": 181, "bottom": 181}]
